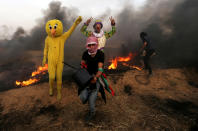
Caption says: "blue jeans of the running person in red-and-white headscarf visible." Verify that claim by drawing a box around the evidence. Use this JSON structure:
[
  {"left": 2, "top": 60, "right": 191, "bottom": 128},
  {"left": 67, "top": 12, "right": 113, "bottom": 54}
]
[{"left": 79, "top": 82, "right": 100, "bottom": 113}]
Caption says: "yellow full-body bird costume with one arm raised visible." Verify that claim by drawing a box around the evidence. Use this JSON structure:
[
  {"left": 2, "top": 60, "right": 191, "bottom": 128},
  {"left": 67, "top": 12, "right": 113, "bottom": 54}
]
[{"left": 42, "top": 16, "right": 82, "bottom": 100}]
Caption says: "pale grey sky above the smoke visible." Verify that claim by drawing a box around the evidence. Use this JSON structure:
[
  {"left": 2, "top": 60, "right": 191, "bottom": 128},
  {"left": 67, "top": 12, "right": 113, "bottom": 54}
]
[{"left": 0, "top": 0, "right": 146, "bottom": 32}]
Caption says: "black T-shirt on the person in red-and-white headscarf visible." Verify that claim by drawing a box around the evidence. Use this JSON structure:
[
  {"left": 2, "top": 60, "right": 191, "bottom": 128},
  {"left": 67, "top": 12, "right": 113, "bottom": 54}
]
[{"left": 82, "top": 50, "right": 104, "bottom": 75}]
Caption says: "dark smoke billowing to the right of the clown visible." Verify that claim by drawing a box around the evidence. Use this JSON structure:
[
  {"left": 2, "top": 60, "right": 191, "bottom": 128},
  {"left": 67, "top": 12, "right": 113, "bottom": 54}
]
[{"left": 111, "top": 0, "right": 198, "bottom": 67}]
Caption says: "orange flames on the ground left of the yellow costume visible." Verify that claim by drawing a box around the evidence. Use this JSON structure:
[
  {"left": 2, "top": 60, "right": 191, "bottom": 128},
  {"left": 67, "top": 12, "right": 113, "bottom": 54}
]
[{"left": 16, "top": 64, "right": 48, "bottom": 86}]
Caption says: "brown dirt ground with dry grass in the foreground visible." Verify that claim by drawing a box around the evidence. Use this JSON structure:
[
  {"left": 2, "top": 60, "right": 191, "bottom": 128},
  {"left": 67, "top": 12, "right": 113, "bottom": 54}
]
[{"left": 0, "top": 68, "right": 198, "bottom": 131}]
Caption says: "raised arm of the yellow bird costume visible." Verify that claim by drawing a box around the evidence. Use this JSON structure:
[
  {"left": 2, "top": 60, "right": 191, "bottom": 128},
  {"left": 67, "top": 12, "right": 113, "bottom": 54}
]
[{"left": 63, "top": 16, "right": 82, "bottom": 40}]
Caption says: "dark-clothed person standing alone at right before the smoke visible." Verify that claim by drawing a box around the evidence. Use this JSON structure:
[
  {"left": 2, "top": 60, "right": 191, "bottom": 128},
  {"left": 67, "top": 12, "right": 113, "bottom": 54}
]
[{"left": 140, "top": 32, "right": 155, "bottom": 75}]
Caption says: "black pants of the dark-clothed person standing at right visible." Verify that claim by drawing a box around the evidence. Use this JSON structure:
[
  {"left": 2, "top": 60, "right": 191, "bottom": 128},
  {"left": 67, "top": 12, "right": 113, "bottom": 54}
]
[{"left": 143, "top": 49, "right": 155, "bottom": 75}]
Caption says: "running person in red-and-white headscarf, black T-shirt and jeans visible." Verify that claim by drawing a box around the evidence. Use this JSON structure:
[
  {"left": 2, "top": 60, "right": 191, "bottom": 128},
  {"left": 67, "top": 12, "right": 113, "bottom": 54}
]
[{"left": 79, "top": 36, "right": 104, "bottom": 121}]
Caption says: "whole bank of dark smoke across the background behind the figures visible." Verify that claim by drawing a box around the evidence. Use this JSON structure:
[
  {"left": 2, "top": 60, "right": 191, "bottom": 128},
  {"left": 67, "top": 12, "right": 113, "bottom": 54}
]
[{"left": 0, "top": 0, "right": 198, "bottom": 66}]
